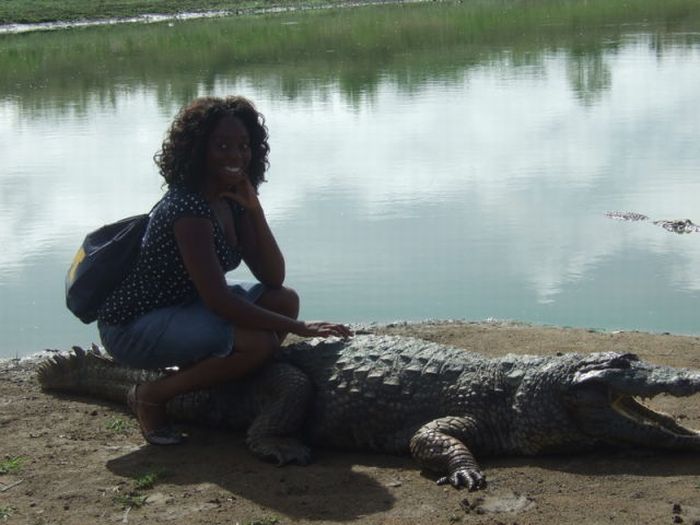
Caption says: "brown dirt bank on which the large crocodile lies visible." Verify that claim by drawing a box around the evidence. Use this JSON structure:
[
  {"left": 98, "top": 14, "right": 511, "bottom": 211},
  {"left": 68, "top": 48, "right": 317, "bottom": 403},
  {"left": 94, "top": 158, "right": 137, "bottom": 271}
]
[{"left": 0, "top": 322, "right": 700, "bottom": 525}]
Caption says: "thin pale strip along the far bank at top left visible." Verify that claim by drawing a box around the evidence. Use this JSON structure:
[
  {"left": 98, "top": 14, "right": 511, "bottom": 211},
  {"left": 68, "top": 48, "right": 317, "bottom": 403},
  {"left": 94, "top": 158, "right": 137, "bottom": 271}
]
[{"left": 0, "top": 0, "right": 430, "bottom": 35}]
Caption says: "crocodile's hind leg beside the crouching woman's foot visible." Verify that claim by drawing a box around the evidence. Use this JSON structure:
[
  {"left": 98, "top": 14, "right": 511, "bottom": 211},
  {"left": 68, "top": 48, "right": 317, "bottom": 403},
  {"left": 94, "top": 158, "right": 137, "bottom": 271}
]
[{"left": 246, "top": 363, "right": 312, "bottom": 466}]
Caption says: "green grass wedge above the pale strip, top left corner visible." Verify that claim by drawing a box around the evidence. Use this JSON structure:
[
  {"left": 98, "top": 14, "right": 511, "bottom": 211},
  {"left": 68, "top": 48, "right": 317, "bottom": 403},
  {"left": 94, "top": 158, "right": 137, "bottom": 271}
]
[{"left": 0, "top": 0, "right": 382, "bottom": 24}]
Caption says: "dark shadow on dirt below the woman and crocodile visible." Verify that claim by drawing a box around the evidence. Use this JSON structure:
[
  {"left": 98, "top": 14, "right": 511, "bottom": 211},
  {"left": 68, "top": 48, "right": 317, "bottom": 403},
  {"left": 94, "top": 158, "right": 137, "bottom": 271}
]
[{"left": 107, "top": 429, "right": 400, "bottom": 521}]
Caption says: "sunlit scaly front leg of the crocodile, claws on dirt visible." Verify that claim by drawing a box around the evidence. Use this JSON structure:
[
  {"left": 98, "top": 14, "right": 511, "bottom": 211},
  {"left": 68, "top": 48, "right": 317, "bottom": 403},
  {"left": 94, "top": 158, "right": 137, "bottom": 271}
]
[{"left": 409, "top": 417, "right": 486, "bottom": 491}]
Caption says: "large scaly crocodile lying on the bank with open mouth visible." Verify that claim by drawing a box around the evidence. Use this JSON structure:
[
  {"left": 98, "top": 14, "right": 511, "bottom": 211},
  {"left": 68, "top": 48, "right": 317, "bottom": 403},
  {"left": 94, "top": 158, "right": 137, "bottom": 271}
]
[{"left": 39, "top": 335, "right": 700, "bottom": 490}]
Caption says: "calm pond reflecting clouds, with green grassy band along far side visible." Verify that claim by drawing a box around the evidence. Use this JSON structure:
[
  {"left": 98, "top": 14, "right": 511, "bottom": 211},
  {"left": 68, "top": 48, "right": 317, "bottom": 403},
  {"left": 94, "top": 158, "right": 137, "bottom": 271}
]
[{"left": 0, "top": 0, "right": 700, "bottom": 357}]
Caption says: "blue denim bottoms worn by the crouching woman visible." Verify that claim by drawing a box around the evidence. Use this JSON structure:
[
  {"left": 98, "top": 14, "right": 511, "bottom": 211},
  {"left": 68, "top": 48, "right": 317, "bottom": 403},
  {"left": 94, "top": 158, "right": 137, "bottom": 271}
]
[{"left": 97, "top": 283, "right": 266, "bottom": 370}]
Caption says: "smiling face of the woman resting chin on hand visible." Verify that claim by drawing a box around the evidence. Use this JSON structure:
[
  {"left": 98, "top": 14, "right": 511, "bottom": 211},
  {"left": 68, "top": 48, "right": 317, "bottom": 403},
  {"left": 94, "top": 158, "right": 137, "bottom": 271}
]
[{"left": 205, "top": 115, "right": 251, "bottom": 191}]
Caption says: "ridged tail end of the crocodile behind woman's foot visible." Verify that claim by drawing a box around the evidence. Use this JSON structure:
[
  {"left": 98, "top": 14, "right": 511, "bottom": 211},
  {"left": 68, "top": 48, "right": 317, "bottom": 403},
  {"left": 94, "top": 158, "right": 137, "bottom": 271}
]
[{"left": 37, "top": 345, "right": 160, "bottom": 404}]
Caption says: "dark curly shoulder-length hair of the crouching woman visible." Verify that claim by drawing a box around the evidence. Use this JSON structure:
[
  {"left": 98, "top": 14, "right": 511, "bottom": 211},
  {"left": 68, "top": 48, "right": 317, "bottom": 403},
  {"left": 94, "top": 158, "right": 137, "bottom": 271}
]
[{"left": 153, "top": 96, "right": 270, "bottom": 191}]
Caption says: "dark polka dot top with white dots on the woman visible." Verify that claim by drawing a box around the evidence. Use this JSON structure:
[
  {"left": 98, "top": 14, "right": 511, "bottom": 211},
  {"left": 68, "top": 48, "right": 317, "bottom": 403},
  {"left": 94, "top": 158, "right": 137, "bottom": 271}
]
[{"left": 98, "top": 187, "right": 243, "bottom": 325}]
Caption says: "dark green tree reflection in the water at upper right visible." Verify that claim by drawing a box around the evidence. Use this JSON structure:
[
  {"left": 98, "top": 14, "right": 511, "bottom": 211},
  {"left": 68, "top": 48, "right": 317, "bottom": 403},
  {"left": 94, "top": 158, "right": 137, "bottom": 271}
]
[{"left": 566, "top": 50, "right": 611, "bottom": 106}]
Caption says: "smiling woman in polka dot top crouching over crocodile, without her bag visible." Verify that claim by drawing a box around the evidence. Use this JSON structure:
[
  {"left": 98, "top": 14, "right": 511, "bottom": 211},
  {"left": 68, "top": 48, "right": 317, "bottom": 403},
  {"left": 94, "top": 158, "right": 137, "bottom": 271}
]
[{"left": 98, "top": 97, "right": 350, "bottom": 445}]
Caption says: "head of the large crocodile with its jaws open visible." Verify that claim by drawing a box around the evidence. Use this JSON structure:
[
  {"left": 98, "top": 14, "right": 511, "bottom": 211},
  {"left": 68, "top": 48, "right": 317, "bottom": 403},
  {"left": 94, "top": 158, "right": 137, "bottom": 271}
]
[{"left": 563, "top": 353, "right": 700, "bottom": 451}]
